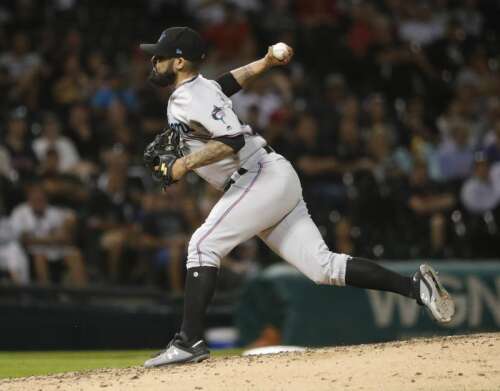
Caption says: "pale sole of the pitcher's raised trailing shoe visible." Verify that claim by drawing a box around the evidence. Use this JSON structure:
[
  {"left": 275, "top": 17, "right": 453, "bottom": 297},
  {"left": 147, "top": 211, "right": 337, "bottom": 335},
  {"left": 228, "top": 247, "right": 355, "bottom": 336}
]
[{"left": 420, "top": 265, "right": 455, "bottom": 323}]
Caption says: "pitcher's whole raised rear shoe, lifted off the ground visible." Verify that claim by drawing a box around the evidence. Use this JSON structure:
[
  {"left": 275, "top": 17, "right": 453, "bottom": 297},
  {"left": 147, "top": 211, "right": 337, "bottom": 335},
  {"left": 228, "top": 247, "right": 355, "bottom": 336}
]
[{"left": 413, "top": 264, "right": 455, "bottom": 323}]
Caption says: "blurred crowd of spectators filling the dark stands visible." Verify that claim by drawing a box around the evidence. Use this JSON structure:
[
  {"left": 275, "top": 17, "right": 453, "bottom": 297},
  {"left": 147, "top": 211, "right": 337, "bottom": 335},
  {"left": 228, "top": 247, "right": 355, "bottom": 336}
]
[{"left": 0, "top": 0, "right": 500, "bottom": 292}]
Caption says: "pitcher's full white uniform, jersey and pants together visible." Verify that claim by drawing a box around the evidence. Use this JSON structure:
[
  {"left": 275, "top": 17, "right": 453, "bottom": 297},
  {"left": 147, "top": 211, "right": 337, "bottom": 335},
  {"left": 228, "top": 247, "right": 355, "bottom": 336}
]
[{"left": 168, "top": 75, "right": 349, "bottom": 286}]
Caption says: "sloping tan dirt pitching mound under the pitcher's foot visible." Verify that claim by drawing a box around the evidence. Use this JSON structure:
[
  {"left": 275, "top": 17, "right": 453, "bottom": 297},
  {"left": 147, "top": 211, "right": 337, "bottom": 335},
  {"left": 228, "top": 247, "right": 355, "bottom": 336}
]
[{"left": 0, "top": 333, "right": 500, "bottom": 391}]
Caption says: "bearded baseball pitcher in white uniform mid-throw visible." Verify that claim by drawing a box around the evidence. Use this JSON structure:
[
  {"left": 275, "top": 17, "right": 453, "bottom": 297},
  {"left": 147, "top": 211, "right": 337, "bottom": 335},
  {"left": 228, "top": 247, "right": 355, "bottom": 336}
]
[{"left": 141, "top": 27, "right": 455, "bottom": 367}]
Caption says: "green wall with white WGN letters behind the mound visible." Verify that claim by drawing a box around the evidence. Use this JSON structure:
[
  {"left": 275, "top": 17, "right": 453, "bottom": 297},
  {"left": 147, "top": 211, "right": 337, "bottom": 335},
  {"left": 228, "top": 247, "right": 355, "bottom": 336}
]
[{"left": 235, "top": 261, "right": 500, "bottom": 346}]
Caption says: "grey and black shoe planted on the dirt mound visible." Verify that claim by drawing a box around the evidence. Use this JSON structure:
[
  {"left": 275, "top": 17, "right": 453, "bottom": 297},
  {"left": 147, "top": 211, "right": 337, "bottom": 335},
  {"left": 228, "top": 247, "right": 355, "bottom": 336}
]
[{"left": 144, "top": 332, "right": 210, "bottom": 368}]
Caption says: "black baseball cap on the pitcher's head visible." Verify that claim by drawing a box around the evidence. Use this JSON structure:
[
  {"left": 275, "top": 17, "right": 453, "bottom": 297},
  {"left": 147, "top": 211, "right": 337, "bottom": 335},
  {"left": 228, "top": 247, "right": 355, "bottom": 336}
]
[{"left": 140, "top": 27, "right": 205, "bottom": 61}]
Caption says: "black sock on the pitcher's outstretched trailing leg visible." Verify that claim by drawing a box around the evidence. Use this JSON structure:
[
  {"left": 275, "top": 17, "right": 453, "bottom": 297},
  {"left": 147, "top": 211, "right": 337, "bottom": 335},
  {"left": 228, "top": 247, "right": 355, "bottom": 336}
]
[{"left": 345, "top": 258, "right": 416, "bottom": 298}]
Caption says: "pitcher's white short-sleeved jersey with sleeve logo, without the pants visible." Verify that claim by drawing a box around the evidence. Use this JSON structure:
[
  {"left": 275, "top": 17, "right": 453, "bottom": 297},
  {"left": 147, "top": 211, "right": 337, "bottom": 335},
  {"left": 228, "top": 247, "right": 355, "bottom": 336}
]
[{"left": 167, "top": 75, "right": 266, "bottom": 189}]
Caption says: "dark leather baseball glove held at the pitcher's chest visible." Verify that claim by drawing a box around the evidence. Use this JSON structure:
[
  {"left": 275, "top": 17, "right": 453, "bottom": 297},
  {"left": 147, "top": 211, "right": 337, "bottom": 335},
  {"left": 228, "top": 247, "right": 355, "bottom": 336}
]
[{"left": 144, "top": 129, "right": 182, "bottom": 187}]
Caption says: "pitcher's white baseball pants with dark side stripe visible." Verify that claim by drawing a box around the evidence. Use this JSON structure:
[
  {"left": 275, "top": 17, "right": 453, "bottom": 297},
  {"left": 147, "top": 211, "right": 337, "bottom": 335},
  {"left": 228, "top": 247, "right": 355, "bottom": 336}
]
[{"left": 187, "top": 149, "right": 350, "bottom": 286}]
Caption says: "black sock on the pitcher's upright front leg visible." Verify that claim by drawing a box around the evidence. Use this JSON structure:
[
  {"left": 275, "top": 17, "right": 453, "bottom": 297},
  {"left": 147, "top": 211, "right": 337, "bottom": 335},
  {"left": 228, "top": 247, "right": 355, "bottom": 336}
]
[{"left": 181, "top": 266, "right": 219, "bottom": 342}]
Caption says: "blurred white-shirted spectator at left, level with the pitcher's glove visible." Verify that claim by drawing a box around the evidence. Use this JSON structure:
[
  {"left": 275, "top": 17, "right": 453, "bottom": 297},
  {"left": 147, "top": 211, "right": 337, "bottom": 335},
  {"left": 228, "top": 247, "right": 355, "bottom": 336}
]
[{"left": 33, "top": 113, "right": 80, "bottom": 172}]
